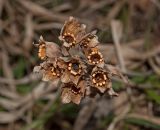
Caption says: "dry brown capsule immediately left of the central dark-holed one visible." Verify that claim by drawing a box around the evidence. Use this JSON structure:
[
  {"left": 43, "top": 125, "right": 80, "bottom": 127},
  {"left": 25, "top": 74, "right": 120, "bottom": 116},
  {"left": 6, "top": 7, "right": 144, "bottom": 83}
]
[{"left": 33, "top": 61, "right": 62, "bottom": 81}]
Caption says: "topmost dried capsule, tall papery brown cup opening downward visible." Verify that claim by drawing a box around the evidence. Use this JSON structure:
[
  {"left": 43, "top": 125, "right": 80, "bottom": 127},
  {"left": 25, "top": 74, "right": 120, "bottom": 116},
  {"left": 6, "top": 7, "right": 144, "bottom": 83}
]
[{"left": 59, "top": 17, "right": 86, "bottom": 48}]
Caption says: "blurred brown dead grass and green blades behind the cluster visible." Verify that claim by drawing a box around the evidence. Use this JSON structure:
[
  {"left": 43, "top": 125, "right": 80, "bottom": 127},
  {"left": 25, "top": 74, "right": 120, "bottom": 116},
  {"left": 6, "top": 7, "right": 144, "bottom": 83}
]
[{"left": 0, "top": 0, "right": 160, "bottom": 130}]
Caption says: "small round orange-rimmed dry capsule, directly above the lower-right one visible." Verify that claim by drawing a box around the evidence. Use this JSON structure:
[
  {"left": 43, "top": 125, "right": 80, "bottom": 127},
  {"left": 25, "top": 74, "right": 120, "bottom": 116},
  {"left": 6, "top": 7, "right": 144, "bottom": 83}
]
[{"left": 85, "top": 48, "right": 104, "bottom": 67}]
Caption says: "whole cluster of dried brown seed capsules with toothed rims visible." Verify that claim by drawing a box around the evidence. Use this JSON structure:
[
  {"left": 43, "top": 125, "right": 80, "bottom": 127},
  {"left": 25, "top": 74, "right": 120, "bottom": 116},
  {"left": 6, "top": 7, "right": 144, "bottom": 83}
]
[{"left": 34, "top": 17, "right": 127, "bottom": 104}]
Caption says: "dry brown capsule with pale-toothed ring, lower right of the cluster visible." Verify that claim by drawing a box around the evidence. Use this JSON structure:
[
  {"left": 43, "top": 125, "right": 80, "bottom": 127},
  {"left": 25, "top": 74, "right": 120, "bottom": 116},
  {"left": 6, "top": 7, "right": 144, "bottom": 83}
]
[{"left": 91, "top": 67, "right": 112, "bottom": 93}]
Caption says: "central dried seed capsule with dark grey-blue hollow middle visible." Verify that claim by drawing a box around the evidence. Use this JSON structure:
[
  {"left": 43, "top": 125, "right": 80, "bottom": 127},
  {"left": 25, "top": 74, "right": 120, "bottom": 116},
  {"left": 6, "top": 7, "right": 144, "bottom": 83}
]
[{"left": 58, "top": 57, "right": 85, "bottom": 84}]
